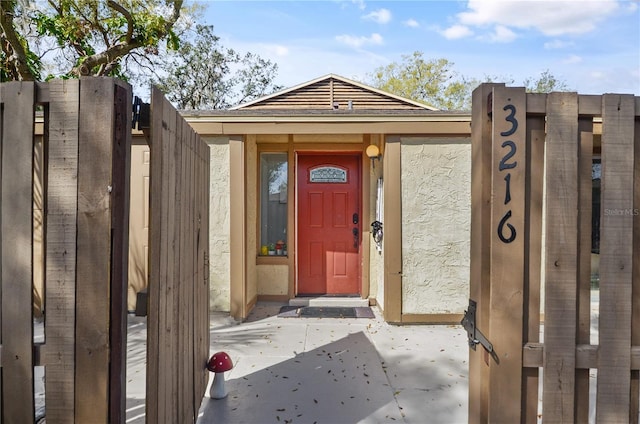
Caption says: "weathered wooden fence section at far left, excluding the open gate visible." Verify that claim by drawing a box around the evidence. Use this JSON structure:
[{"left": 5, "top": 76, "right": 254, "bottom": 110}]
[{"left": 0, "top": 78, "right": 131, "bottom": 423}]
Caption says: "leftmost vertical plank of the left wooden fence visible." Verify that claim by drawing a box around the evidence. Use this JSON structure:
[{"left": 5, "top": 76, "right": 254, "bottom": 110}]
[{"left": 0, "top": 82, "right": 35, "bottom": 423}]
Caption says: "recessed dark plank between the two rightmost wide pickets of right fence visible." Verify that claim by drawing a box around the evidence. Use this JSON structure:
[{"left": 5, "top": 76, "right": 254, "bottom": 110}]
[{"left": 575, "top": 116, "right": 593, "bottom": 423}]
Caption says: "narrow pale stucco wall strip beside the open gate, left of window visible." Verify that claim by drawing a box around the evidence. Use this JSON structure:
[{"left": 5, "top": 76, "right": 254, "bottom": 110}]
[{"left": 203, "top": 137, "right": 231, "bottom": 311}]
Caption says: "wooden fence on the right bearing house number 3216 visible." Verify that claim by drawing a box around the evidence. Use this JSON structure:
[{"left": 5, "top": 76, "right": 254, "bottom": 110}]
[{"left": 463, "top": 84, "right": 640, "bottom": 424}]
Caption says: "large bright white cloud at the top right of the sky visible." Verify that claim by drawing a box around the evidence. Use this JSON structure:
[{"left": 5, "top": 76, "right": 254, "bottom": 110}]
[{"left": 457, "top": 0, "right": 619, "bottom": 36}]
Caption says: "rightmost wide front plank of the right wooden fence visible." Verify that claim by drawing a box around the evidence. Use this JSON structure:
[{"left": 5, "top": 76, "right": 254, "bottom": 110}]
[{"left": 596, "top": 94, "right": 634, "bottom": 423}]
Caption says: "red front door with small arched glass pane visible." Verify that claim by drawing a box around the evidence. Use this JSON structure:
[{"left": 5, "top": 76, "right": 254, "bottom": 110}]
[{"left": 297, "top": 154, "right": 362, "bottom": 295}]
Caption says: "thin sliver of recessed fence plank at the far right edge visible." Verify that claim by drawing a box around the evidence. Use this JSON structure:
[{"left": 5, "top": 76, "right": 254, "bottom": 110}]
[{"left": 629, "top": 101, "right": 640, "bottom": 424}]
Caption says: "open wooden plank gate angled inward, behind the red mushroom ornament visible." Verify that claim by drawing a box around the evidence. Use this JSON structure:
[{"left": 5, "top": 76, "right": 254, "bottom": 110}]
[{"left": 147, "top": 88, "right": 209, "bottom": 423}]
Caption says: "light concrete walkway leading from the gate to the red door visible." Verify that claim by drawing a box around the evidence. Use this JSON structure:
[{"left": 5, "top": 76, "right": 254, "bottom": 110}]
[{"left": 127, "top": 303, "right": 469, "bottom": 424}]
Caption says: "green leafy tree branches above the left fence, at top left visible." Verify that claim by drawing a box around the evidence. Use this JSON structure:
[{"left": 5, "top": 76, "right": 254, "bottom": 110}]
[{"left": 0, "top": 0, "right": 184, "bottom": 79}]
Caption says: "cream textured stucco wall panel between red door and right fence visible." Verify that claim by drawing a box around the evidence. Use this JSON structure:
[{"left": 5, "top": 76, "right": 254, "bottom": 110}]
[{"left": 401, "top": 138, "right": 471, "bottom": 314}]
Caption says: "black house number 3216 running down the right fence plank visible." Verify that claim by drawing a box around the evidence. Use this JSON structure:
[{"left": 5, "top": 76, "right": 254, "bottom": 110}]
[{"left": 498, "top": 104, "right": 518, "bottom": 243}]
